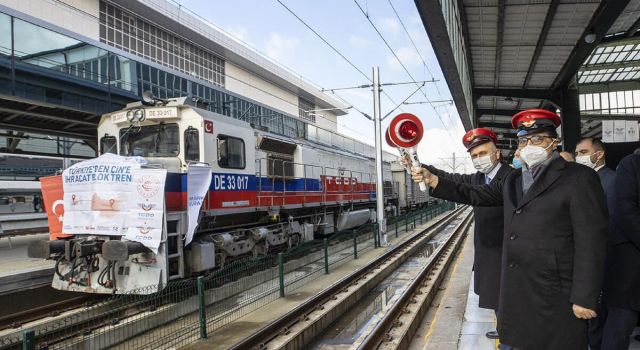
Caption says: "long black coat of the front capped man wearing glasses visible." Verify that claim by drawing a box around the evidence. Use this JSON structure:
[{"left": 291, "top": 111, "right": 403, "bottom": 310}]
[{"left": 433, "top": 158, "right": 607, "bottom": 350}]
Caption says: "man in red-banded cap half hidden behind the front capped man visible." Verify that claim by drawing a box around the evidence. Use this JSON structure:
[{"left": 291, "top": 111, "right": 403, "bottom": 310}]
[{"left": 403, "top": 128, "right": 513, "bottom": 339}]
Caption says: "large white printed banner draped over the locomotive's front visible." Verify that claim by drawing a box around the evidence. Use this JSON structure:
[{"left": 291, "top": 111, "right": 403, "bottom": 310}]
[{"left": 62, "top": 153, "right": 167, "bottom": 252}]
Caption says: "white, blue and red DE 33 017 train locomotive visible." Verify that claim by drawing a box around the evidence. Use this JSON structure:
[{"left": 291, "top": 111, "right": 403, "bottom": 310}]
[{"left": 29, "top": 97, "right": 429, "bottom": 294}]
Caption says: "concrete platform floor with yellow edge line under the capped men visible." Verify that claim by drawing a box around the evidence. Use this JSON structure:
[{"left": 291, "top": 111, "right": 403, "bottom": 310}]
[{"left": 410, "top": 230, "right": 640, "bottom": 350}]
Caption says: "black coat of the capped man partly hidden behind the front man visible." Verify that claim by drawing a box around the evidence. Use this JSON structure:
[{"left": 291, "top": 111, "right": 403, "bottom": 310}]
[{"left": 426, "top": 163, "right": 513, "bottom": 310}]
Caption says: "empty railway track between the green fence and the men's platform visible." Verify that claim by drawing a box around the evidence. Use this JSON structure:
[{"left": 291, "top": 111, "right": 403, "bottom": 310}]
[{"left": 232, "top": 207, "right": 472, "bottom": 350}]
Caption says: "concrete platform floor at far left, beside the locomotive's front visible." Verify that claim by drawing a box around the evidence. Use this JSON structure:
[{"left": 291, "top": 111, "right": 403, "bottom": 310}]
[{"left": 0, "top": 233, "right": 54, "bottom": 278}]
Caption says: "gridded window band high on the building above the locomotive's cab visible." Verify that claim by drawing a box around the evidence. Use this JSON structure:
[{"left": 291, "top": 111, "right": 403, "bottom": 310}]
[{"left": 100, "top": 1, "right": 224, "bottom": 86}]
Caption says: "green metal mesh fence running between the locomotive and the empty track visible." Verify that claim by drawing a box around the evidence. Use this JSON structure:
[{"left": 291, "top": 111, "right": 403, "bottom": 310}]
[{"left": 5, "top": 202, "right": 455, "bottom": 349}]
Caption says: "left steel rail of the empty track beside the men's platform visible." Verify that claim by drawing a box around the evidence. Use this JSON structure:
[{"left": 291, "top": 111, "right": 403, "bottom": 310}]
[{"left": 229, "top": 206, "right": 467, "bottom": 350}]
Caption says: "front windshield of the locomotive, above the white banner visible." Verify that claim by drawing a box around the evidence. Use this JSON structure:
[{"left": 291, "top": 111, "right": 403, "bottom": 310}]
[{"left": 120, "top": 123, "right": 180, "bottom": 157}]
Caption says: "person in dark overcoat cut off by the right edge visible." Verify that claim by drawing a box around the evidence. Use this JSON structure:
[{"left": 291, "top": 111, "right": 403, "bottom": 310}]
[{"left": 601, "top": 155, "right": 640, "bottom": 350}]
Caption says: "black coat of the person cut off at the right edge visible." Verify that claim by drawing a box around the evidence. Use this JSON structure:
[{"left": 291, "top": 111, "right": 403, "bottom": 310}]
[{"left": 604, "top": 155, "right": 640, "bottom": 311}]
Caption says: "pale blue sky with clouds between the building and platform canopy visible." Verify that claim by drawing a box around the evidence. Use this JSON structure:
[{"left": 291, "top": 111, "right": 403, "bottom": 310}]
[{"left": 175, "top": 0, "right": 472, "bottom": 172}]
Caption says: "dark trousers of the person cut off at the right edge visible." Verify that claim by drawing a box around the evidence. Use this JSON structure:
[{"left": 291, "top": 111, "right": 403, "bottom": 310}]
[{"left": 601, "top": 306, "right": 640, "bottom": 350}]
